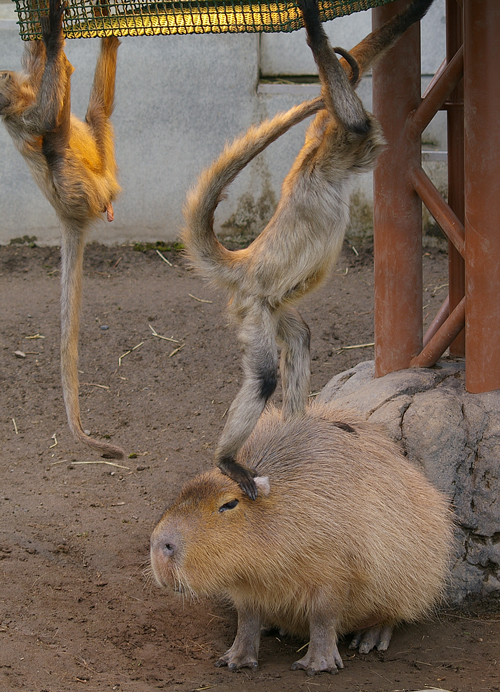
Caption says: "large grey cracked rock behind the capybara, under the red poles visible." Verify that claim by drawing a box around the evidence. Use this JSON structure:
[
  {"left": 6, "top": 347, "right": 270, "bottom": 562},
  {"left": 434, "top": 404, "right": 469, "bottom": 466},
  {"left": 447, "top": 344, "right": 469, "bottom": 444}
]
[{"left": 318, "top": 360, "right": 500, "bottom": 602}]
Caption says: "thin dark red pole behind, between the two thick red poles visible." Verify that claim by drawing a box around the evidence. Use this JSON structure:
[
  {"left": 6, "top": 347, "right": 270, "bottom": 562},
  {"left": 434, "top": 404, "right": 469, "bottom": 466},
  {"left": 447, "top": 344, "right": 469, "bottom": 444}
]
[{"left": 446, "top": 0, "right": 465, "bottom": 356}]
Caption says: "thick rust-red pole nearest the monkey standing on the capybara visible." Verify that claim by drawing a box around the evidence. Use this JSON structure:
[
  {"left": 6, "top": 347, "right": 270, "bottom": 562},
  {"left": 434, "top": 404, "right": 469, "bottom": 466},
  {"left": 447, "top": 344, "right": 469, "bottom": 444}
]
[{"left": 372, "top": 0, "right": 422, "bottom": 377}]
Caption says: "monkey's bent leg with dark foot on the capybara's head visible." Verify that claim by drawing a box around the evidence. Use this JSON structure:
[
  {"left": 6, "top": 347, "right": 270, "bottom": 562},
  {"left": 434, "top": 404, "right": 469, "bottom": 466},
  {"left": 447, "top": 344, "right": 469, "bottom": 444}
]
[{"left": 215, "top": 304, "right": 278, "bottom": 500}]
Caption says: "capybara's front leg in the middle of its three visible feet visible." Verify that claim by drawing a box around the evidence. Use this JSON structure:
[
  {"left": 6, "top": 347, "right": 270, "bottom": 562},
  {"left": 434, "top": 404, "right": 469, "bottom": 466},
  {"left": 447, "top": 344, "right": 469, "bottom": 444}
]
[{"left": 292, "top": 618, "right": 344, "bottom": 675}]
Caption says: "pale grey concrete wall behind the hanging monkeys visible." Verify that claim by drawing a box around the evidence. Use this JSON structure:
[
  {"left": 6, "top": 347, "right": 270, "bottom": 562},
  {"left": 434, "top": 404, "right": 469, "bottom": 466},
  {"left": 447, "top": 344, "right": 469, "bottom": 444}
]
[{"left": 0, "top": 0, "right": 445, "bottom": 245}]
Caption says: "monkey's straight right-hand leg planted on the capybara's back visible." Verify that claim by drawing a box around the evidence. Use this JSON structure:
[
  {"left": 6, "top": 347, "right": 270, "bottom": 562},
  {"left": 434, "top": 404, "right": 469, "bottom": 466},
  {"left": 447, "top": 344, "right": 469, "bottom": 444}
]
[{"left": 278, "top": 308, "right": 311, "bottom": 419}]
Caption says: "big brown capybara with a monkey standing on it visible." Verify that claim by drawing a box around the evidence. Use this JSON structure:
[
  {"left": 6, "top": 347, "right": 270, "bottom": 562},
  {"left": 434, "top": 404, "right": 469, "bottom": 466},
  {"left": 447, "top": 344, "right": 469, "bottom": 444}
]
[{"left": 151, "top": 405, "right": 452, "bottom": 674}]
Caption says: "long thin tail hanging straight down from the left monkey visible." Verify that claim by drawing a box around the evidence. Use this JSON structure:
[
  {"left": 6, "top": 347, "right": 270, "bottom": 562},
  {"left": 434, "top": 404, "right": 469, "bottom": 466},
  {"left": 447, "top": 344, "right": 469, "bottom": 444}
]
[{"left": 61, "top": 227, "right": 124, "bottom": 459}]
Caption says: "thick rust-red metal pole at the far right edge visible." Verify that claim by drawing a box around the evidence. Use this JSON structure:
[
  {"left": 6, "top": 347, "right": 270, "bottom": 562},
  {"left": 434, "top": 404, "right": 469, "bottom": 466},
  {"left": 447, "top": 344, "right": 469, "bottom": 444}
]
[{"left": 464, "top": 0, "right": 500, "bottom": 393}]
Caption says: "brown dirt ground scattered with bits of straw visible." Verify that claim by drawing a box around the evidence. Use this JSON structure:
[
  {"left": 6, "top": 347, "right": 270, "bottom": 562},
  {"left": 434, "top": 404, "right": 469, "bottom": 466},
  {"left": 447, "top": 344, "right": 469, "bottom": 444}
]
[{"left": 0, "top": 239, "right": 500, "bottom": 692}]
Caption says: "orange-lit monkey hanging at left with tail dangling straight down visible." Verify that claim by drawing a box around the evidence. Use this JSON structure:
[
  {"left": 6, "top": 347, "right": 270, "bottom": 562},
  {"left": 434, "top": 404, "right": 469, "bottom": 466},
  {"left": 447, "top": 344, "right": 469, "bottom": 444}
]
[{"left": 0, "top": 0, "right": 124, "bottom": 459}]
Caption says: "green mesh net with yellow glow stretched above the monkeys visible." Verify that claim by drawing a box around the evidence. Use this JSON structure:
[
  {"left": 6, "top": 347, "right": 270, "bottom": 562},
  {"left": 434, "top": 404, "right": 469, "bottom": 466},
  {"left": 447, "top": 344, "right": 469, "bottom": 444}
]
[{"left": 15, "top": 0, "right": 398, "bottom": 41}]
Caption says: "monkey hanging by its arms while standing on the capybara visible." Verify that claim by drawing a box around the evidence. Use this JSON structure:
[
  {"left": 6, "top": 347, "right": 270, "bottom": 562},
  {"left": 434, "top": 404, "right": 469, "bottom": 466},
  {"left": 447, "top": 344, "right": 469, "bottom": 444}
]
[{"left": 182, "top": 0, "right": 432, "bottom": 499}]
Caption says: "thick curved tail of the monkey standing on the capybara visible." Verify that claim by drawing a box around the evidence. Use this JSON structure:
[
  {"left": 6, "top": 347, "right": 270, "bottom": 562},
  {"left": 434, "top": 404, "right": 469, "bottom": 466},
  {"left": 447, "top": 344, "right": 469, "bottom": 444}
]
[{"left": 181, "top": 97, "right": 324, "bottom": 285}]
